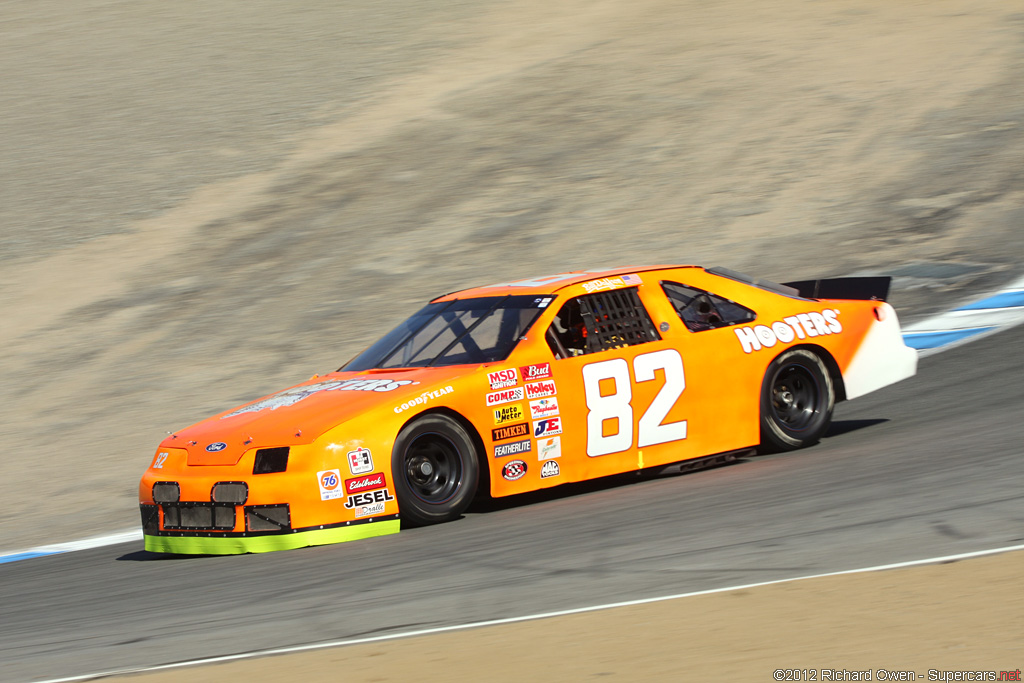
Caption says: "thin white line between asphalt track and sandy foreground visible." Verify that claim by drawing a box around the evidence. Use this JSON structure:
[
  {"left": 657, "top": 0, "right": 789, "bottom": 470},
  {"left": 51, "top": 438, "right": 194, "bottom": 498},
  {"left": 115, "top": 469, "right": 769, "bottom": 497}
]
[{"left": 32, "top": 545, "right": 1024, "bottom": 683}]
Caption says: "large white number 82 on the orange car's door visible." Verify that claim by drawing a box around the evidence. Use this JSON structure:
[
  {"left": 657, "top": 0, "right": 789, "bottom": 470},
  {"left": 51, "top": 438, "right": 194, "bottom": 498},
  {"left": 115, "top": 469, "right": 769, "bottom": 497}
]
[{"left": 583, "top": 348, "right": 686, "bottom": 458}]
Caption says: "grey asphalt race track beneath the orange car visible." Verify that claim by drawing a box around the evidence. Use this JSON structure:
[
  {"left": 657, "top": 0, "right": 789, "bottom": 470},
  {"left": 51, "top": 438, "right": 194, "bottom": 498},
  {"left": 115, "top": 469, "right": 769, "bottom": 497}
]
[{"left": 0, "top": 328, "right": 1024, "bottom": 681}]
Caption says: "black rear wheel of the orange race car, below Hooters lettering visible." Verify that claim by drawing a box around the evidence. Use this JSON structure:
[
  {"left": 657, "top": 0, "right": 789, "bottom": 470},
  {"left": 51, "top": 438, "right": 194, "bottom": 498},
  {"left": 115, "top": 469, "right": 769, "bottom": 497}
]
[{"left": 761, "top": 348, "right": 836, "bottom": 453}]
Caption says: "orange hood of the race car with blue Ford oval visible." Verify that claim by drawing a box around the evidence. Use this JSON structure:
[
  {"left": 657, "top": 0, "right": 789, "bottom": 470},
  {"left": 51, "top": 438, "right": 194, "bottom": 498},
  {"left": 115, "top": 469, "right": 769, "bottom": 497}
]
[{"left": 161, "top": 368, "right": 465, "bottom": 465}]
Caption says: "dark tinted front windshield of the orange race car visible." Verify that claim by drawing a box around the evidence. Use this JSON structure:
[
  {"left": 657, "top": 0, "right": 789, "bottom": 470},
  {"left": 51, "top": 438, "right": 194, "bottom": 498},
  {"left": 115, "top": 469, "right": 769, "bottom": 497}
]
[{"left": 342, "top": 296, "right": 554, "bottom": 372}]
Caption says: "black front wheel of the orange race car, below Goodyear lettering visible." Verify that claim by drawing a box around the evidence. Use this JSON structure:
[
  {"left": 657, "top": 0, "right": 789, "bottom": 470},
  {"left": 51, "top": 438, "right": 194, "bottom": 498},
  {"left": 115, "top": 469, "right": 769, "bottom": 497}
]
[{"left": 391, "top": 414, "right": 480, "bottom": 526}]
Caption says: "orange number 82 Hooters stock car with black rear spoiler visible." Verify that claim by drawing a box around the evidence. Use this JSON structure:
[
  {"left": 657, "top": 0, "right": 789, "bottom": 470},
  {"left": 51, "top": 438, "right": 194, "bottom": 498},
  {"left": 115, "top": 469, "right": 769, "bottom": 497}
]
[{"left": 138, "top": 266, "right": 918, "bottom": 554}]
